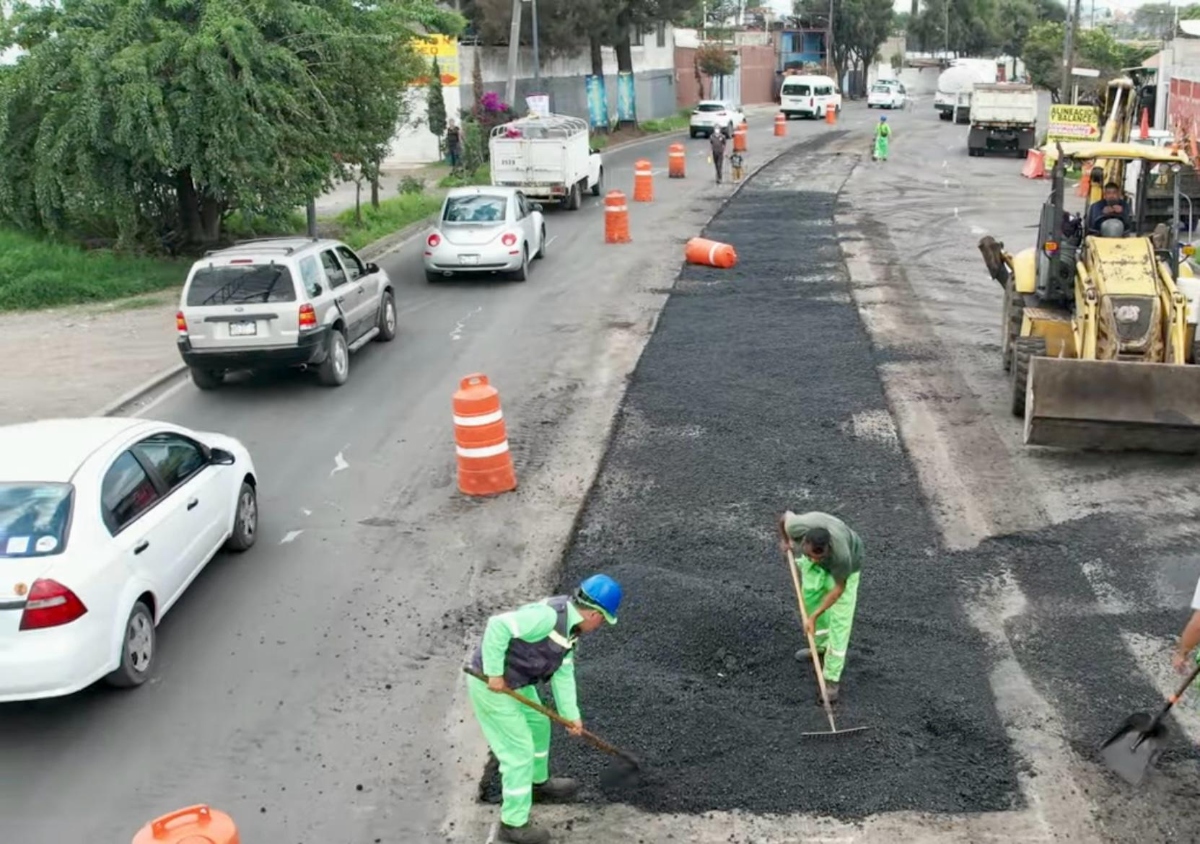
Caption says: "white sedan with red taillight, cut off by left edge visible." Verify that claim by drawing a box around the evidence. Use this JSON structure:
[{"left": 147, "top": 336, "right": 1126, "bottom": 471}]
[{"left": 0, "top": 418, "right": 258, "bottom": 702}]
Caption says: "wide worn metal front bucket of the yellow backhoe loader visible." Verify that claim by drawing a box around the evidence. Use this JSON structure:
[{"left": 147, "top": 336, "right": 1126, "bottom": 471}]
[{"left": 1025, "top": 358, "right": 1200, "bottom": 454}]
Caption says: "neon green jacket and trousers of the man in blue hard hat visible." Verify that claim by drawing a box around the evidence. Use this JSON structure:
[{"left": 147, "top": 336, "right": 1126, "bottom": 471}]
[{"left": 467, "top": 603, "right": 583, "bottom": 826}]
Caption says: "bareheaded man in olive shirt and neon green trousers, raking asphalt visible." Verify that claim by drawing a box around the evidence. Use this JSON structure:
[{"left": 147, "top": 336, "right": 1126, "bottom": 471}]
[{"left": 779, "top": 510, "right": 863, "bottom": 702}]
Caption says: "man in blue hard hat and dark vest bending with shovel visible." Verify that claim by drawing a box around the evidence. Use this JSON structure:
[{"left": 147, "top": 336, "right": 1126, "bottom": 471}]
[{"left": 467, "top": 574, "right": 622, "bottom": 844}]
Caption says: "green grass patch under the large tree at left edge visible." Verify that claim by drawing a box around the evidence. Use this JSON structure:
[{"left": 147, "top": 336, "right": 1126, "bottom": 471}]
[{"left": 0, "top": 229, "right": 191, "bottom": 311}]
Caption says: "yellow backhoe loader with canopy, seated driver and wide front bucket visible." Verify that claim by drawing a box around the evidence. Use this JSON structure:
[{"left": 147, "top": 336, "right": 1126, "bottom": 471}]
[{"left": 979, "top": 142, "right": 1200, "bottom": 454}]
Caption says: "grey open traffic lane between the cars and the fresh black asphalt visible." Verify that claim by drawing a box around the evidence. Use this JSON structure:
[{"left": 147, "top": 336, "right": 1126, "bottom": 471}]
[{"left": 0, "top": 112, "right": 865, "bottom": 844}]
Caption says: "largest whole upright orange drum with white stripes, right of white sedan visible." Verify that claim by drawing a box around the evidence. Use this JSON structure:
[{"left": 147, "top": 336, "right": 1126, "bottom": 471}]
[{"left": 454, "top": 372, "right": 517, "bottom": 496}]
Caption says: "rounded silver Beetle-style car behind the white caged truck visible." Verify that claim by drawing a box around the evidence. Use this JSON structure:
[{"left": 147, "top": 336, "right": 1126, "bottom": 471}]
[{"left": 425, "top": 185, "right": 546, "bottom": 282}]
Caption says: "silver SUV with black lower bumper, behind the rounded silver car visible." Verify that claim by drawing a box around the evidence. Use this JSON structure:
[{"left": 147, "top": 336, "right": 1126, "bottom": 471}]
[{"left": 175, "top": 237, "right": 396, "bottom": 390}]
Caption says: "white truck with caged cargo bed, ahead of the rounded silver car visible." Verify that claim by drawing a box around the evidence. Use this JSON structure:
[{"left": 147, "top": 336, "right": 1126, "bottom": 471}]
[{"left": 488, "top": 114, "right": 604, "bottom": 211}]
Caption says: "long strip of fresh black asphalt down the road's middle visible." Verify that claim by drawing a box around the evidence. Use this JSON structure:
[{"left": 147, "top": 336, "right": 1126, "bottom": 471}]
[{"left": 484, "top": 141, "right": 1019, "bottom": 818}]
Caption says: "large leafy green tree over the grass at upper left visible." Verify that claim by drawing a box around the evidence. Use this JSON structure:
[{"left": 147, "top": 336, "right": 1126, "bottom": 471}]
[{"left": 0, "top": 0, "right": 461, "bottom": 245}]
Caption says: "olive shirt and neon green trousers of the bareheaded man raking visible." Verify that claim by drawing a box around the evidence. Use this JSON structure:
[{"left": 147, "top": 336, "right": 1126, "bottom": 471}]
[{"left": 784, "top": 513, "right": 863, "bottom": 683}]
